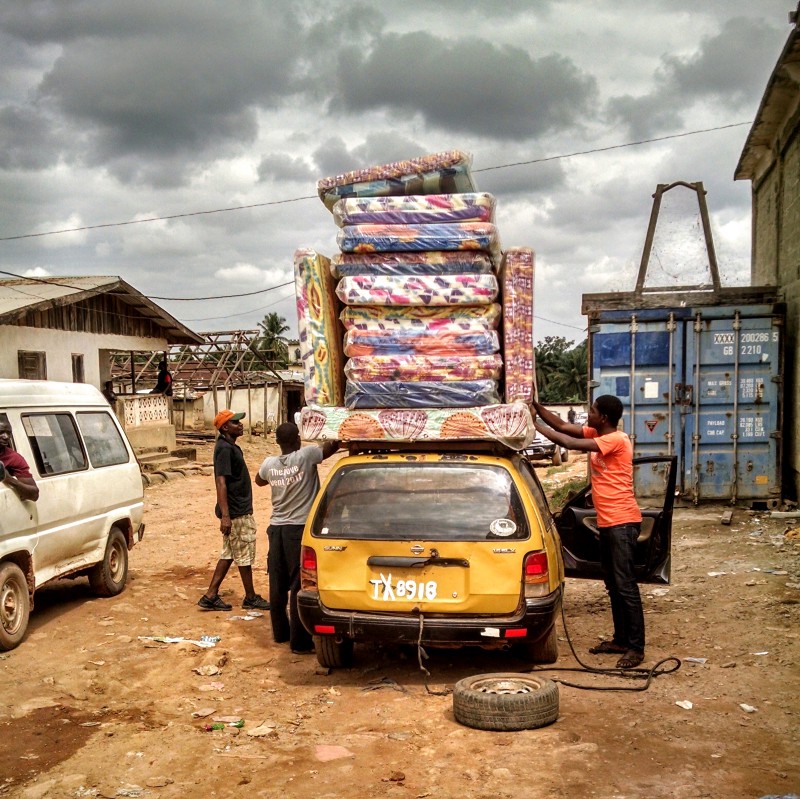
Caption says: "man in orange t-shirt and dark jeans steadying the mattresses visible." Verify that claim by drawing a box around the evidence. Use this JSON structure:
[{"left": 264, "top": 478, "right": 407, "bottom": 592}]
[{"left": 532, "top": 394, "right": 644, "bottom": 669}]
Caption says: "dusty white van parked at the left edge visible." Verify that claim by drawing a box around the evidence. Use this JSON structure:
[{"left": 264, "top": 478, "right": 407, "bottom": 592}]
[{"left": 0, "top": 380, "right": 144, "bottom": 650}]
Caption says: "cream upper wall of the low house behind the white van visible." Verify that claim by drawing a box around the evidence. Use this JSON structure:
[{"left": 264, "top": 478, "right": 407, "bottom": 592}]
[{"left": 0, "top": 325, "right": 167, "bottom": 388}]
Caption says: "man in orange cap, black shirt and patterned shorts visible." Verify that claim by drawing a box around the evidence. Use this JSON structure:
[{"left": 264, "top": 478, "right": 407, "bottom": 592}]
[{"left": 197, "top": 409, "right": 269, "bottom": 610}]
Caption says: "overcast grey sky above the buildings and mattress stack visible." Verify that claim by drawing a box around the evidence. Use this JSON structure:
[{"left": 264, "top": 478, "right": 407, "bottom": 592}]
[{"left": 0, "top": 0, "right": 797, "bottom": 342}]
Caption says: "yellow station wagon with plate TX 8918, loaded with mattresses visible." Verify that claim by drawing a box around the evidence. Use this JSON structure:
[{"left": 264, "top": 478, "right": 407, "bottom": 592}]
[{"left": 298, "top": 444, "right": 671, "bottom": 668}]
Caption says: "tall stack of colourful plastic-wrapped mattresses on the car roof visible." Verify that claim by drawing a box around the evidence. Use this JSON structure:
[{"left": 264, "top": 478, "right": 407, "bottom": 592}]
[{"left": 295, "top": 151, "right": 534, "bottom": 446}]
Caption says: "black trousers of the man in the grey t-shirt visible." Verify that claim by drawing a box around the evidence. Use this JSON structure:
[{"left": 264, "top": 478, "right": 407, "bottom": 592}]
[{"left": 267, "top": 524, "right": 314, "bottom": 650}]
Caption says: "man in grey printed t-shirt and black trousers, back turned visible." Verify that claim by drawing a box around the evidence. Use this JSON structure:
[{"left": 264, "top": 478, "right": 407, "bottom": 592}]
[{"left": 256, "top": 422, "right": 339, "bottom": 655}]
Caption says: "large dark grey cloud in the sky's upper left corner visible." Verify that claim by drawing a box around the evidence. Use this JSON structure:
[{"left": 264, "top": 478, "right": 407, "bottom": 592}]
[{"left": 2, "top": 2, "right": 299, "bottom": 182}]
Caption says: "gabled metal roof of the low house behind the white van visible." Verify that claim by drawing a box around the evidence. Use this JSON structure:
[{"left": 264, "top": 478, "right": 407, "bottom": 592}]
[{"left": 0, "top": 275, "right": 204, "bottom": 344}]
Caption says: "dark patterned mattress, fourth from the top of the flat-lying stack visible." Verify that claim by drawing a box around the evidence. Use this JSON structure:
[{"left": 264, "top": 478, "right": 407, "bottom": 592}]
[{"left": 331, "top": 250, "right": 494, "bottom": 277}]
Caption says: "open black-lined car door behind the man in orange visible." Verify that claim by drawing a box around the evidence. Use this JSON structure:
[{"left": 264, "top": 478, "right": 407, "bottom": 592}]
[{"left": 555, "top": 455, "right": 678, "bottom": 583}]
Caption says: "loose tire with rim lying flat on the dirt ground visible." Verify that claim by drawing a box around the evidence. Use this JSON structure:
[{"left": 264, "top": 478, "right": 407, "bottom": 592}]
[{"left": 453, "top": 674, "right": 558, "bottom": 731}]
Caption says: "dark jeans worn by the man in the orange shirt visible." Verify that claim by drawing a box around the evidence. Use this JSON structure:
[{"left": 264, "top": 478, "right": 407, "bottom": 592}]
[{"left": 600, "top": 523, "right": 644, "bottom": 652}]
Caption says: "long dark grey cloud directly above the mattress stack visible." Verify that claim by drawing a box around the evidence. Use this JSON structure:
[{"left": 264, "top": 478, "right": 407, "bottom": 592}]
[{"left": 331, "top": 31, "right": 596, "bottom": 140}]
